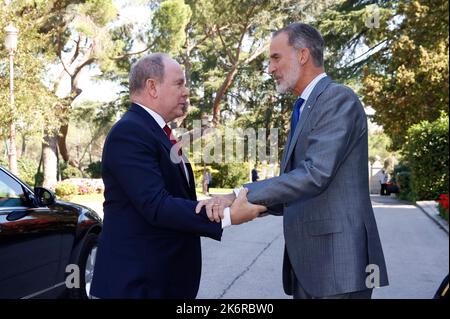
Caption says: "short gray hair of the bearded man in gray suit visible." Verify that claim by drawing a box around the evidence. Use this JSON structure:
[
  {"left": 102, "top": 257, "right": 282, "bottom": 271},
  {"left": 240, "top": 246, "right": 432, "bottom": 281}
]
[{"left": 272, "top": 23, "right": 324, "bottom": 67}]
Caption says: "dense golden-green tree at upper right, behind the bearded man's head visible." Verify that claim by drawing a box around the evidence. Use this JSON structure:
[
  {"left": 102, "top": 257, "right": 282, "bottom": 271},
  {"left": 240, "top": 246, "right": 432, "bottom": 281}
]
[{"left": 316, "top": 0, "right": 448, "bottom": 150}]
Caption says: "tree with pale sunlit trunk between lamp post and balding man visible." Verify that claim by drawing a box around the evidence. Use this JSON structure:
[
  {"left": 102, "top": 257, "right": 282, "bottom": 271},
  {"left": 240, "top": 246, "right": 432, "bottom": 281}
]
[{"left": 2, "top": 0, "right": 142, "bottom": 186}]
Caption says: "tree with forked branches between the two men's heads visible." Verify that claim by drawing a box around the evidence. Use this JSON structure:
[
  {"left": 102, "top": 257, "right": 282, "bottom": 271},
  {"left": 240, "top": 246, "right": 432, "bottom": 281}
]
[{"left": 149, "top": 0, "right": 323, "bottom": 125}]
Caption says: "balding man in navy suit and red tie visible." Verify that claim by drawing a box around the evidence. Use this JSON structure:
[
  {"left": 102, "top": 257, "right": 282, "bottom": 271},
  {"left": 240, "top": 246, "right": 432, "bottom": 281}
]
[{"left": 90, "top": 53, "right": 265, "bottom": 298}]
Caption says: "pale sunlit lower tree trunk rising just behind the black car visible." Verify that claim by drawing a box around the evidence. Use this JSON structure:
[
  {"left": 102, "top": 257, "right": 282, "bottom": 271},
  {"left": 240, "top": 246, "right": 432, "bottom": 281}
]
[{"left": 42, "top": 134, "right": 58, "bottom": 189}]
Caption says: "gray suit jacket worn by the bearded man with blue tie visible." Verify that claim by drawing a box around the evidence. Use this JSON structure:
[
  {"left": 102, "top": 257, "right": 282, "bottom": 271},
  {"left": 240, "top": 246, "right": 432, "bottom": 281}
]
[{"left": 245, "top": 77, "right": 388, "bottom": 297}]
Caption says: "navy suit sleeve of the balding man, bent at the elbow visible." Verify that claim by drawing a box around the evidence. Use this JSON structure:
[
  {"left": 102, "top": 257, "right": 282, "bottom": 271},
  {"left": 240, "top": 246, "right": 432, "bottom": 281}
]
[{"left": 104, "top": 122, "right": 222, "bottom": 240}]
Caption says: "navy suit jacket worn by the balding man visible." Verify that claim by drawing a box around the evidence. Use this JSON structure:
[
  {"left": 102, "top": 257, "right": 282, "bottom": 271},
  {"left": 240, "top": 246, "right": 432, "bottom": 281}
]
[{"left": 91, "top": 104, "right": 222, "bottom": 298}]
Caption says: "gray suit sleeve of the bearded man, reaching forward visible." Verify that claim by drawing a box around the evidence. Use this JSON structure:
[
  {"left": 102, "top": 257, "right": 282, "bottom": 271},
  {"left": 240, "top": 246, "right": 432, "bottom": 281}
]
[{"left": 245, "top": 86, "right": 366, "bottom": 206}]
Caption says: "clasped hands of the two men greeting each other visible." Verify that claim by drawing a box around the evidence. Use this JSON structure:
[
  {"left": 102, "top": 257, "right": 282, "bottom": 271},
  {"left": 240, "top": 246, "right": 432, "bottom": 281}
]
[{"left": 195, "top": 188, "right": 267, "bottom": 225}]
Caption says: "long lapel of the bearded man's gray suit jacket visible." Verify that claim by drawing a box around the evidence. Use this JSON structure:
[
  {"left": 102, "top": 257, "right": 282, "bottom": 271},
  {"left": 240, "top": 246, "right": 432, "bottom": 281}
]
[{"left": 280, "top": 76, "right": 331, "bottom": 172}]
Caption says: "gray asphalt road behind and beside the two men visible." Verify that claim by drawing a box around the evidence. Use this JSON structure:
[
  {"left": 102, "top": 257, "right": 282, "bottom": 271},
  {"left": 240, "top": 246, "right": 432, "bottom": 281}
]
[{"left": 197, "top": 196, "right": 449, "bottom": 299}]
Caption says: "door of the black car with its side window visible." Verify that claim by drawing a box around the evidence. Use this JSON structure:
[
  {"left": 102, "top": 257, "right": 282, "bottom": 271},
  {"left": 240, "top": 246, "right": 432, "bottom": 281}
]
[{"left": 0, "top": 169, "right": 64, "bottom": 298}]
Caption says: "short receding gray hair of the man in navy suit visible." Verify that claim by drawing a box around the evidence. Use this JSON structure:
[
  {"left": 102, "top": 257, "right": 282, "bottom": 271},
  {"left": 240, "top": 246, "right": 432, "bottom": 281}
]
[{"left": 129, "top": 53, "right": 169, "bottom": 94}]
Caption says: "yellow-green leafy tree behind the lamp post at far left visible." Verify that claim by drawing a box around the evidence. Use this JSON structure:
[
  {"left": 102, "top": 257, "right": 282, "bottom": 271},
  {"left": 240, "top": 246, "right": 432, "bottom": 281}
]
[{"left": 0, "top": 0, "right": 58, "bottom": 176}]
